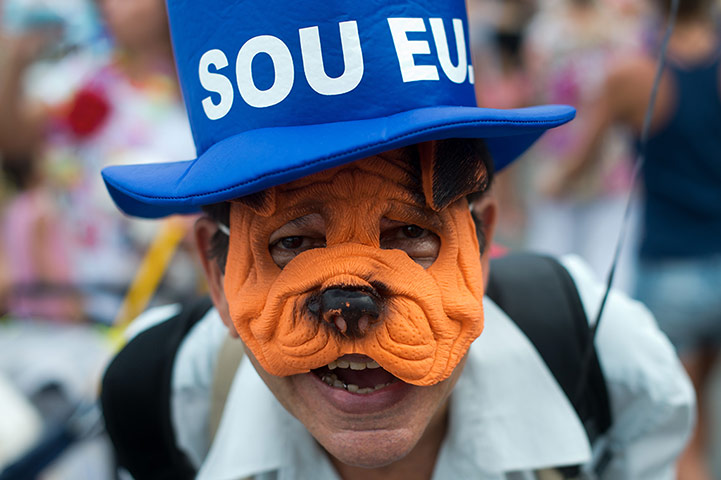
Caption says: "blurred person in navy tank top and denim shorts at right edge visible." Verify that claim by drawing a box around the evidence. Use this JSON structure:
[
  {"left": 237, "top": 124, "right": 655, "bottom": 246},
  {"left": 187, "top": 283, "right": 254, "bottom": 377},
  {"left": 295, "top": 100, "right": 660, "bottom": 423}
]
[{"left": 551, "top": 0, "right": 721, "bottom": 480}]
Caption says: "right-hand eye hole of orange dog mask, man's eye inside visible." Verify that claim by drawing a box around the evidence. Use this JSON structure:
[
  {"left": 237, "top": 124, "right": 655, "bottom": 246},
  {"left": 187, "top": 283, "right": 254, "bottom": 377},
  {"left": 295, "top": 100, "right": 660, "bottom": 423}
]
[{"left": 380, "top": 218, "right": 441, "bottom": 268}]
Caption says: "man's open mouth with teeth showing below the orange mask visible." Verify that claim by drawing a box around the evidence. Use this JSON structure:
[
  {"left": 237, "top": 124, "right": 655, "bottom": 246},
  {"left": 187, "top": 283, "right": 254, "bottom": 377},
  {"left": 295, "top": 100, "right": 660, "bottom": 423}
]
[{"left": 313, "top": 355, "right": 398, "bottom": 395}]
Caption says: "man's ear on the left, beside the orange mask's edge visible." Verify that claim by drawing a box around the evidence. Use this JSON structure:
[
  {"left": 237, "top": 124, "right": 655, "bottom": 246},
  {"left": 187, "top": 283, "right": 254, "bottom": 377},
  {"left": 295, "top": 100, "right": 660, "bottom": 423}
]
[{"left": 195, "top": 217, "right": 238, "bottom": 338}]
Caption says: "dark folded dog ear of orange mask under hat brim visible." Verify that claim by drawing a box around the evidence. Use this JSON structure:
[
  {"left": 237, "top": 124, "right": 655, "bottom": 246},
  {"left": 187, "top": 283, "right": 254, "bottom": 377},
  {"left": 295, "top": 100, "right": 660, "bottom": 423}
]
[{"left": 418, "top": 138, "right": 492, "bottom": 211}]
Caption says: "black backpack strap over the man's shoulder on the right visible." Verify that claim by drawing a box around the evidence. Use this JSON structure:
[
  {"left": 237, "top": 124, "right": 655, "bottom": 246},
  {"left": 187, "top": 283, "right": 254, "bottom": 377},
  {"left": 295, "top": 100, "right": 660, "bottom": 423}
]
[{"left": 486, "top": 253, "right": 611, "bottom": 442}]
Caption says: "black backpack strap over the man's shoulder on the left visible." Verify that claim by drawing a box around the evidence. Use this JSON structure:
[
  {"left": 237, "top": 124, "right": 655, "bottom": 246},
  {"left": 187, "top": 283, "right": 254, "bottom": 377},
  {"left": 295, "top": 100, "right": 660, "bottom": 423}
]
[{"left": 100, "top": 297, "right": 212, "bottom": 480}]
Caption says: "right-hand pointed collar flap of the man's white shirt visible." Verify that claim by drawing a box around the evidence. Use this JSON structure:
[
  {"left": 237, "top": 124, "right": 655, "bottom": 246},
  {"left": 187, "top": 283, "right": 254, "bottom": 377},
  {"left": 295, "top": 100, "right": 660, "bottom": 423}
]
[{"left": 437, "top": 297, "right": 591, "bottom": 478}]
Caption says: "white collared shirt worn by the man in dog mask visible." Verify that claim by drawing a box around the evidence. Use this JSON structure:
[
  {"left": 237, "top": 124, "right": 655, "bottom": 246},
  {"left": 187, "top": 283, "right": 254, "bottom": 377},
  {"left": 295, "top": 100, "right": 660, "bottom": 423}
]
[{"left": 167, "top": 257, "right": 694, "bottom": 480}]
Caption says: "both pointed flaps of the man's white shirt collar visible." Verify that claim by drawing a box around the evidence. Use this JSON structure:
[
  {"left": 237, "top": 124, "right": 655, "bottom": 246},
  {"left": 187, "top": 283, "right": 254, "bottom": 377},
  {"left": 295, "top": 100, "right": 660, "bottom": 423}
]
[{"left": 197, "top": 297, "right": 591, "bottom": 480}]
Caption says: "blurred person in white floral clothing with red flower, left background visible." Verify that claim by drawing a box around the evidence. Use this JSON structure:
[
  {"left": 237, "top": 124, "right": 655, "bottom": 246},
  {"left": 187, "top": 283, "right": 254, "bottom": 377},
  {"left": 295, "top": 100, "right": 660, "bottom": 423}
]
[{"left": 0, "top": 0, "right": 196, "bottom": 323}]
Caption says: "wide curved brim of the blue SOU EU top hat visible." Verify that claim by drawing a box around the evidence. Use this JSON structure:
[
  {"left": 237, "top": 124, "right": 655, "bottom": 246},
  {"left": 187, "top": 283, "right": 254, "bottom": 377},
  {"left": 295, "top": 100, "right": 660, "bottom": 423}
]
[{"left": 103, "top": 105, "right": 575, "bottom": 218}]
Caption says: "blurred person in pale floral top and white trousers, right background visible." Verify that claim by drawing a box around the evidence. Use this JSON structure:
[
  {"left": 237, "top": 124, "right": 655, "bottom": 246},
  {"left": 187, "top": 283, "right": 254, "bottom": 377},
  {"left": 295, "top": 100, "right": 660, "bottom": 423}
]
[{"left": 517, "top": 0, "right": 637, "bottom": 289}]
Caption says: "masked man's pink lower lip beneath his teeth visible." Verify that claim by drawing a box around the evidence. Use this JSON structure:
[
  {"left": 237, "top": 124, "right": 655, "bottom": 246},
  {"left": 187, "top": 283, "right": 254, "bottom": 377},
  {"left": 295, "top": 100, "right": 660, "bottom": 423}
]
[{"left": 306, "top": 373, "right": 413, "bottom": 414}]
